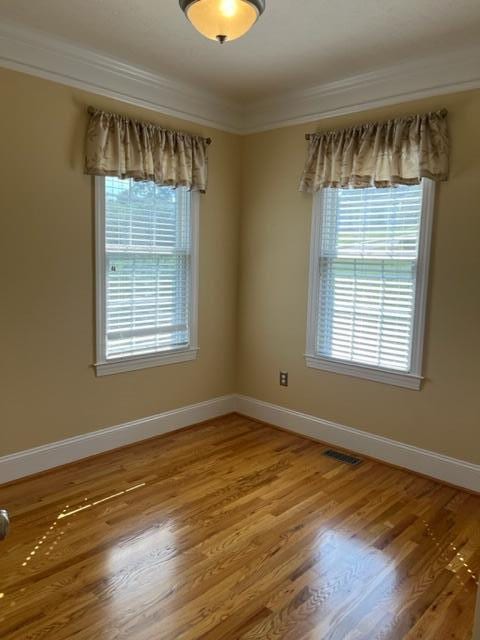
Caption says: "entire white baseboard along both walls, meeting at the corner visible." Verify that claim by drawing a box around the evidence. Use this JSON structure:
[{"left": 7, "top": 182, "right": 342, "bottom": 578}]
[{"left": 0, "top": 395, "right": 480, "bottom": 492}]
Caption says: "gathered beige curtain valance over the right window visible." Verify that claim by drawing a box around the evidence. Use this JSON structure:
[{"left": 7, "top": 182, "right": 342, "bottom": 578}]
[{"left": 300, "top": 110, "right": 449, "bottom": 193}]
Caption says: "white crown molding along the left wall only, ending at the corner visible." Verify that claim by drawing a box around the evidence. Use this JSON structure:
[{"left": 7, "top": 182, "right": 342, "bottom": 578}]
[{"left": 0, "top": 23, "right": 242, "bottom": 133}]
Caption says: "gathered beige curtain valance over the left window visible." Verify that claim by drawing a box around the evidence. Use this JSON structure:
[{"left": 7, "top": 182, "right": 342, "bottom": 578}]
[{"left": 85, "top": 107, "right": 210, "bottom": 192}]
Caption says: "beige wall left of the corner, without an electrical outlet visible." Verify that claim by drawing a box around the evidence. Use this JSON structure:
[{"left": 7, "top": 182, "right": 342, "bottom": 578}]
[{"left": 0, "top": 69, "right": 240, "bottom": 455}]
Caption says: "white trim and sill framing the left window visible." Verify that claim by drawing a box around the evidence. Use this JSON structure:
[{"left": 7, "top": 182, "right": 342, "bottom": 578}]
[{"left": 94, "top": 176, "right": 200, "bottom": 376}]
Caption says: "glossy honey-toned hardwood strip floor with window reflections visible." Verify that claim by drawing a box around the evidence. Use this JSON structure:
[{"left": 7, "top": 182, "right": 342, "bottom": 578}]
[{"left": 0, "top": 415, "right": 480, "bottom": 640}]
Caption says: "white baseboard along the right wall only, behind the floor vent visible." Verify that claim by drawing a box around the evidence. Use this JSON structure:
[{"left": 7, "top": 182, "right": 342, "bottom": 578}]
[{"left": 236, "top": 395, "right": 480, "bottom": 492}]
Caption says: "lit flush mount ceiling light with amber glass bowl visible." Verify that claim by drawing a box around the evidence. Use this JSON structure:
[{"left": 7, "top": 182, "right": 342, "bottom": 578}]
[{"left": 180, "top": 0, "right": 265, "bottom": 44}]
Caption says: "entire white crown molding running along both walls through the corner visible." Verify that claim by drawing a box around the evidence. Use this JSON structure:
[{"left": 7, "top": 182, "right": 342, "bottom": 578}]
[{"left": 0, "top": 23, "right": 480, "bottom": 135}]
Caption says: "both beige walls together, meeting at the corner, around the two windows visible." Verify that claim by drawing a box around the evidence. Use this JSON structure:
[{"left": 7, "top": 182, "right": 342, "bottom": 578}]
[{"left": 0, "top": 69, "right": 480, "bottom": 462}]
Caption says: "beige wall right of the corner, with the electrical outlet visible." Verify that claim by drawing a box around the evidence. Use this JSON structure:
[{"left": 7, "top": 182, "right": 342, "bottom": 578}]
[{"left": 237, "top": 91, "right": 480, "bottom": 463}]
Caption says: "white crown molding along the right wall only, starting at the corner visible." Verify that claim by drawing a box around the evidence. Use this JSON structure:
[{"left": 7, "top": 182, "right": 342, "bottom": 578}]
[{"left": 244, "top": 45, "right": 480, "bottom": 133}]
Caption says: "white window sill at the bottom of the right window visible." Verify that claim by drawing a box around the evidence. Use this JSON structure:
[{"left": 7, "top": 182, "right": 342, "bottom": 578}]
[{"left": 305, "top": 354, "right": 423, "bottom": 391}]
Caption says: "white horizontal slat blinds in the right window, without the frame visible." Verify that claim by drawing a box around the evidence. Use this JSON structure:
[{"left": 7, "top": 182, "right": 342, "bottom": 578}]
[{"left": 314, "top": 185, "right": 423, "bottom": 373}]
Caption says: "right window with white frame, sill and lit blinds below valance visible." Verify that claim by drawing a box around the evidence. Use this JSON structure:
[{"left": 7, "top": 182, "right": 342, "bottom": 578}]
[{"left": 306, "top": 180, "right": 434, "bottom": 389}]
